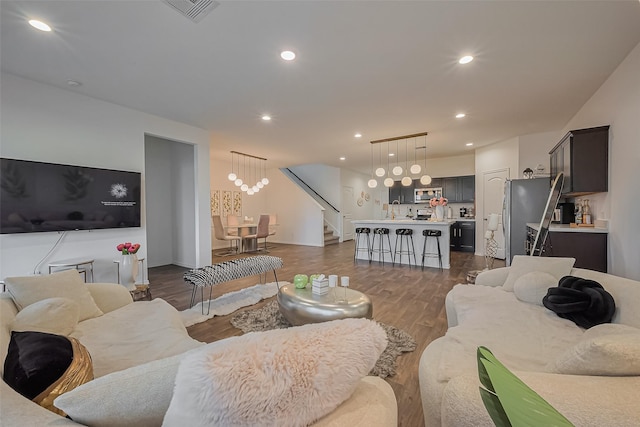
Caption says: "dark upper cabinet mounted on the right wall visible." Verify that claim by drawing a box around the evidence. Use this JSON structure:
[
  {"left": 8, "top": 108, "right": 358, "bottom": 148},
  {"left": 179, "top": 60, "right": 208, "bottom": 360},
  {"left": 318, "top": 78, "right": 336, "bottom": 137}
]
[{"left": 549, "top": 126, "right": 609, "bottom": 196}]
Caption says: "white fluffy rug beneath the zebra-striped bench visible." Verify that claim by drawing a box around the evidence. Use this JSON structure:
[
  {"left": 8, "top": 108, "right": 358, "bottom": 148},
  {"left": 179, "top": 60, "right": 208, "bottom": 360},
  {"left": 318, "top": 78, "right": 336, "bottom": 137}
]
[{"left": 180, "top": 282, "right": 288, "bottom": 326}]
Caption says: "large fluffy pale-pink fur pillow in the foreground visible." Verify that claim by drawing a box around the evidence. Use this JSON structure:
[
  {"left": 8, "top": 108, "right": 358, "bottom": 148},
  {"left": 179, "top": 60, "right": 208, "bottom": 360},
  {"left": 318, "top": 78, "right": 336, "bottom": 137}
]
[{"left": 162, "top": 319, "right": 387, "bottom": 427}]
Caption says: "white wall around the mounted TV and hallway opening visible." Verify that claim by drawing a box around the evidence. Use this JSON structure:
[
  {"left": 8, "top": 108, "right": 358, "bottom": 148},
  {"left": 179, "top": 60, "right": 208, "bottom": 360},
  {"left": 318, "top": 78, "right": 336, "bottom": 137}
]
[{"left": 0, "top": 73, "right": 211, "bottom": 281}]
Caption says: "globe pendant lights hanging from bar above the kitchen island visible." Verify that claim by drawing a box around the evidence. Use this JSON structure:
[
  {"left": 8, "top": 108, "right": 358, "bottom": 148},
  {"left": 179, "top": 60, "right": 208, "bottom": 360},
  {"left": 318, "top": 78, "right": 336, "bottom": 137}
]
[{"left": 367, "top": 132, "right": 431, "bottom": 188}]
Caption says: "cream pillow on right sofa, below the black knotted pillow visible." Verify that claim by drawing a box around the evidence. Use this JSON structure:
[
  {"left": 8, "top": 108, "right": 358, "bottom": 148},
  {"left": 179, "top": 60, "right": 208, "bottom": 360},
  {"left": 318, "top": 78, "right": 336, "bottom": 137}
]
[{"left": 547, "top": 324, "right": 640, "bottom": 376}]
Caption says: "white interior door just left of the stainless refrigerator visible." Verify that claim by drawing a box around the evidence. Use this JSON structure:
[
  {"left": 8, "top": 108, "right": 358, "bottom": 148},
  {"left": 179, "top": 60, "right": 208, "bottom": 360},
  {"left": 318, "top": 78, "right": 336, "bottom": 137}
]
[{"left": 478, "top": 168, "right": 509, "bottom": 259}]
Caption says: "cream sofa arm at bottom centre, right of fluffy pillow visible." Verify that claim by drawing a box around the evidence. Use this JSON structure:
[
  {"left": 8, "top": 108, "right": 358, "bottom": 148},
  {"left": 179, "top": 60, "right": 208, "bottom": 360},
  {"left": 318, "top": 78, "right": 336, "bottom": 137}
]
[{"left": 312, "top": 377, "right": 398, "bottom": 427}]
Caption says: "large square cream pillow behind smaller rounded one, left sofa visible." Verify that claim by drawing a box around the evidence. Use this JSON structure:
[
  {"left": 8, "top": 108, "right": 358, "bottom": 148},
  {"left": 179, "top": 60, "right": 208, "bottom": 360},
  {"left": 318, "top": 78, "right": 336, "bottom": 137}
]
[{"left": 4, "top": 270, "right": 103, "bottom": 322}]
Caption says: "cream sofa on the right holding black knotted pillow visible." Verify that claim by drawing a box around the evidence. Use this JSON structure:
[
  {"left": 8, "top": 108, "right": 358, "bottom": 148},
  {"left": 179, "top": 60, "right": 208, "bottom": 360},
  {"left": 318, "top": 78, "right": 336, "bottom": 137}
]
[{"left": 419, "top": 258, "right": 640, "bottom": 427}]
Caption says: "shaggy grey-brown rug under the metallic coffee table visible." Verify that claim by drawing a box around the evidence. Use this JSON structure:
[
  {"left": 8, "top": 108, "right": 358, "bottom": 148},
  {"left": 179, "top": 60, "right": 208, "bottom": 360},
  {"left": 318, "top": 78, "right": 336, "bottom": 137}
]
[{"left": 231, "top": 301, "right": 416, "bottom": 378}]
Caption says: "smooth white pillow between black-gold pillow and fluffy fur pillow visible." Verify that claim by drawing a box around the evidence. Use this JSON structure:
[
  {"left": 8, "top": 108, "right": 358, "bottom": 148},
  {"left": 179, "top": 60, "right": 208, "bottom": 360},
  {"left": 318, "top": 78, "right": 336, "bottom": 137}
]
[{"left": 53, "top": 350, "right": 188, "bottom": 427}]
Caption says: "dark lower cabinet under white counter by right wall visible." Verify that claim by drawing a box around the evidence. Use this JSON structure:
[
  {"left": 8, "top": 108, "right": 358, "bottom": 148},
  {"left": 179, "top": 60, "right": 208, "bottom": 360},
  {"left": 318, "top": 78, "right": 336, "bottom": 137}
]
[{"left": 526, "top": 227, "right": 607, "bottom": 273}]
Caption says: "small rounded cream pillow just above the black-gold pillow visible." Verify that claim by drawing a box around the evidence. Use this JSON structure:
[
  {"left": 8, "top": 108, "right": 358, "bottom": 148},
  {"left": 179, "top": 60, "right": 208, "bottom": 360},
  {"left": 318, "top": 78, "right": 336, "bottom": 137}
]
[{"left": 11, "top": 298, "right": 78, "bottom": 336}]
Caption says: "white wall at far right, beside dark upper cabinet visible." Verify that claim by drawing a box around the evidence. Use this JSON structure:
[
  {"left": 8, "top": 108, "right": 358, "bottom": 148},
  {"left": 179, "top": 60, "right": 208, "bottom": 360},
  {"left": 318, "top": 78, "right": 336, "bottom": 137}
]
[{"left": 563, "top": 44, "right": 640, "bottom": 280}]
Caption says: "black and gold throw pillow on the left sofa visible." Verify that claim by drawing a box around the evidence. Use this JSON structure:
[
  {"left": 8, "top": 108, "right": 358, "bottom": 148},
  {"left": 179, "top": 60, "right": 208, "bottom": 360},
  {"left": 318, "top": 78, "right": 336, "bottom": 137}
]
[{"left": 3, "top": 332, "right": 93, "bottom": 416}]
